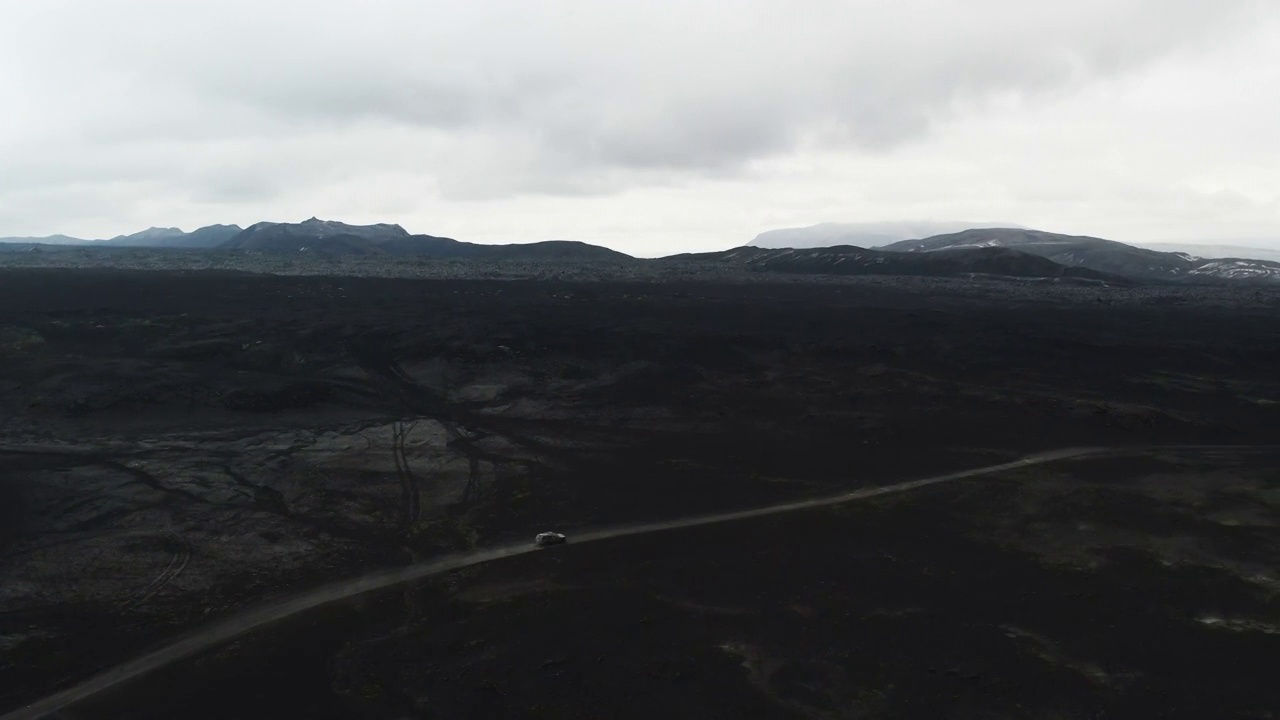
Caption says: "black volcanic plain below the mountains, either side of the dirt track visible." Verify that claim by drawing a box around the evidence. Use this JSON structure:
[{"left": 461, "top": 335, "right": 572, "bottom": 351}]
[{"left": 0, "top": 265, "right": 1280, "bottom": 719}]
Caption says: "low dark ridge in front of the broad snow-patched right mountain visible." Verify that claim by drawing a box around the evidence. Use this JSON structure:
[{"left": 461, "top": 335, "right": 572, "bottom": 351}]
[{"left": 667, "top": 245, "right": 1128, "bottom": 283}]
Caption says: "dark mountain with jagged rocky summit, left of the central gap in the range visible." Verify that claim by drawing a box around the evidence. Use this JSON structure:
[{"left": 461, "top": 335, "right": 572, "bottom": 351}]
[{"left": 221, "top": 218, "right": 632, "bottom": 260}]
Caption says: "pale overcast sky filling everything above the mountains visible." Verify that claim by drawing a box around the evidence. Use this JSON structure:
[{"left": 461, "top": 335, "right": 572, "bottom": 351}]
[{"left": 0, "top": 0, "right": 1280, "bottom": 255}]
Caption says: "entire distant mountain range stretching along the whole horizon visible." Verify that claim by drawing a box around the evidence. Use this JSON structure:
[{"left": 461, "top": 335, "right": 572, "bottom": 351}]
[{"left": 0, "top": 218, "right": 1280, "bottom": 283}]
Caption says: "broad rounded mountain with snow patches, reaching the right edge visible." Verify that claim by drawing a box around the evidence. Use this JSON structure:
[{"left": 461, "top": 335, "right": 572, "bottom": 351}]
[{"left": 883, "top": 228, "right": 1280, "bottom": 282}]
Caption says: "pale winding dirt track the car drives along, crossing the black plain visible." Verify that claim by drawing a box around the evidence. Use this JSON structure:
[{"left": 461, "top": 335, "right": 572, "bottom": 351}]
[{"left": 0, "top": 447, "right": 1111, "bottom": 720}]
